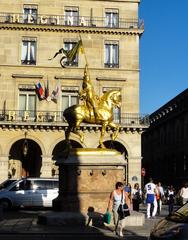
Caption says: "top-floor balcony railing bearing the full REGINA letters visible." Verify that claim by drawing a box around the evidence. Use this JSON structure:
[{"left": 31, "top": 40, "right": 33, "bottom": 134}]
[{"left": 0, "top": 13, "right": 144, "bottom": 29}]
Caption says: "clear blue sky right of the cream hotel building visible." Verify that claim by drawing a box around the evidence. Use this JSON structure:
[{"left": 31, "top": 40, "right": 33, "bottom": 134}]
[{"left": 139, "top": 0, "right": 188, "bottom": 114}]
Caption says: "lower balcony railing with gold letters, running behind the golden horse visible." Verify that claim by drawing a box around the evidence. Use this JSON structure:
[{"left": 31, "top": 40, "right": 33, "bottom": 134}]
[{"left": 0, "top": 110, "right": 149, "bottom": 126}]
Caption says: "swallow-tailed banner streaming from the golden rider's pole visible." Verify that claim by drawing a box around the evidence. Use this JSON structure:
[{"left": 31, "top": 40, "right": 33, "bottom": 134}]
[{"left": 48, "top": 40, "right": 83, "bottom": 68}]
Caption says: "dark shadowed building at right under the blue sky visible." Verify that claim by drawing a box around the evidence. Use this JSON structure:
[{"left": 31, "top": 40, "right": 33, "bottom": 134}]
[{"left": 142, "top": 89, "right": 188, "bottom": 187}]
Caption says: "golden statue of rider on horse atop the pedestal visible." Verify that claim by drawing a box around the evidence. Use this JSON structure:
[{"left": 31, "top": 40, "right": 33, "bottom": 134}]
[{"left": 63, "top": 65, "right": 121, "bottom": 148}]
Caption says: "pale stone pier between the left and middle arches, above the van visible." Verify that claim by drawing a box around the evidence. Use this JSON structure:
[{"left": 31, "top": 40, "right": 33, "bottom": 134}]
[{"left": 40, "top": 155, "right": 52, "bottom": 177}]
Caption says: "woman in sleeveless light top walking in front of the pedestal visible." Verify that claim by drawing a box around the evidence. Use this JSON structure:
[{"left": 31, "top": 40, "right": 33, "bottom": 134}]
[{"left": 107, "top": 182, "right": 128, "bottom": 237}]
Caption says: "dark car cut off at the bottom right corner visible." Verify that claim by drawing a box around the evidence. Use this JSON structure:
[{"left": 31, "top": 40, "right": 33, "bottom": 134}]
[{"left": 150, "top": 203, "right": 188, "bottom": 240}]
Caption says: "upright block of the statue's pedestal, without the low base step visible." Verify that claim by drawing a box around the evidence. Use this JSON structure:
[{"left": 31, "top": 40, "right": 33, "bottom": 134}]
[{"left": 53, "top": 148, "right": 126, "bottom": 215}]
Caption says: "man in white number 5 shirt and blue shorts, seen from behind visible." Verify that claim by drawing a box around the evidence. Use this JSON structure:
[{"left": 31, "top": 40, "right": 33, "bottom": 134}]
[{"left": 144, "top": 179, "right": 157, "bottom": 218}]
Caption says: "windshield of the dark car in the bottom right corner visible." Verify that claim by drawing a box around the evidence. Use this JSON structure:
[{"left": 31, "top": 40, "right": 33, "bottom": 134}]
[{"left": 167, "top": 203, "right": 188, "bottom": 222}]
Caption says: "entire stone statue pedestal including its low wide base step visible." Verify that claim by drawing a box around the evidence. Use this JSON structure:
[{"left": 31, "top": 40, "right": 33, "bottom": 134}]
[{"left": 38, "top": 149, "right": 145, "bottom": 226}]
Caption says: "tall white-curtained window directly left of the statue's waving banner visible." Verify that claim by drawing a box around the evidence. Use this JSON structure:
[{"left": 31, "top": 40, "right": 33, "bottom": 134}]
[{"left": 21, "top": 38, "right": 36, "bottom": 65}]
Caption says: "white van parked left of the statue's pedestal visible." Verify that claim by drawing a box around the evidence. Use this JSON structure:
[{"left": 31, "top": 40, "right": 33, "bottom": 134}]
[{"left": 0, "top": 178, "right": 59, "bottom": 209}]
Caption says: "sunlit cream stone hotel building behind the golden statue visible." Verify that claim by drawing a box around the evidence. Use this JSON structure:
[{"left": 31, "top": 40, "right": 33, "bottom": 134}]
[{"left": 0, "top": 0, "right": 148, "bottom": 186}]
